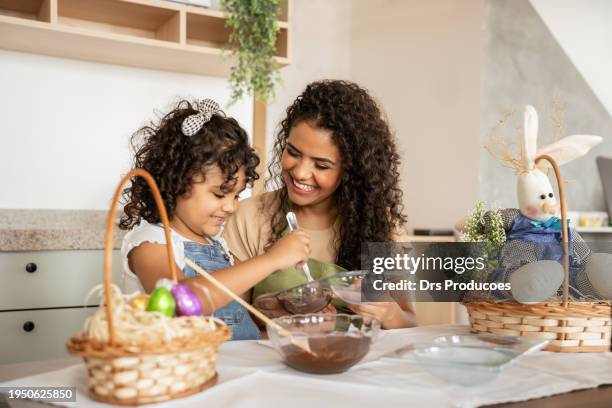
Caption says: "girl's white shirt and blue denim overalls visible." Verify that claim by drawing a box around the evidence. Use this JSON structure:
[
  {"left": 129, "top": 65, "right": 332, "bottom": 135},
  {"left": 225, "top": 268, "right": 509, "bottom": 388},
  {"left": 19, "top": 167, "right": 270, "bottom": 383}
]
[{"left": 121, "top": 220, "right": 260, "bottom": 340}]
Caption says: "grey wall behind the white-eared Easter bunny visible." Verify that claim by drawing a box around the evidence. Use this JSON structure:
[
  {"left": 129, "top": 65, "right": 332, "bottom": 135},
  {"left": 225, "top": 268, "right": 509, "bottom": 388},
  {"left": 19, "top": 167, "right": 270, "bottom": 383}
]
[{"left": 480, "top": 0, "right": 612, "bottom": 211}]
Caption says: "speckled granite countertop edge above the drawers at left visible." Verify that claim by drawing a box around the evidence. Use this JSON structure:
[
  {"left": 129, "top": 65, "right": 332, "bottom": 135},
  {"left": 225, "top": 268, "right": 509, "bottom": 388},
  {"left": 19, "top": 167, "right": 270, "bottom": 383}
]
[{"left": 0, "top": 209, "right": 126, "bottom": 251}]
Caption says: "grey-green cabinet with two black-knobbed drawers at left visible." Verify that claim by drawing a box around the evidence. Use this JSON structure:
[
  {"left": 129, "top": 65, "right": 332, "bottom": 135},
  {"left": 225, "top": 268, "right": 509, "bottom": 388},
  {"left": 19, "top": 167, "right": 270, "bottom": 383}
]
[{"left": 0, "top": 250, "right": 121, "bottom": 364}]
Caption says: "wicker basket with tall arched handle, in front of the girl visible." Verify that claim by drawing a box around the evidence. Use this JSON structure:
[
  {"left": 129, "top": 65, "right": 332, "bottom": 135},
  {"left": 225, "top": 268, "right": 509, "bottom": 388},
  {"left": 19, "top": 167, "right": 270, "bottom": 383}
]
[{"left": 66, "top": 169, "right": 231, "bottom": 405}]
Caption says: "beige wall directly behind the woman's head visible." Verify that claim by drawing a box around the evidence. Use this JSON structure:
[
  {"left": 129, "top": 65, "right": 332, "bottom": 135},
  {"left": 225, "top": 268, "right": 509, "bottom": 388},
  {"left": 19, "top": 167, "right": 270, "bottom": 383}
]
[{"left": 267, "top": 0, "right": 482, "bottom": 233}]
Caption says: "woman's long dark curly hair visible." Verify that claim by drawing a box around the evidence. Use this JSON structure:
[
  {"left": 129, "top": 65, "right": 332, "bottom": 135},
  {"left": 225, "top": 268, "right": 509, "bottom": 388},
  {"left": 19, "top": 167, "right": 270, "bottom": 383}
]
[{"left": 267, "top": 80, "right": 406, "bottom": 269}]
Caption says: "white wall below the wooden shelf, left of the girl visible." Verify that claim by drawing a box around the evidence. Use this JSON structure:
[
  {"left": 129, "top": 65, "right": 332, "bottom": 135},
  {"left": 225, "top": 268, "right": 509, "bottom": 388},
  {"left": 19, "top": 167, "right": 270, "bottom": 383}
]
[{"left": 0, "top": 50, "right": 252, "bottom": 209}]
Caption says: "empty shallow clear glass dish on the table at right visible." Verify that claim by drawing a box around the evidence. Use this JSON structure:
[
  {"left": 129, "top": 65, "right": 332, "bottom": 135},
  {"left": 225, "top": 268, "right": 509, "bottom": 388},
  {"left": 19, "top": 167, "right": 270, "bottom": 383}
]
[{"left": 413, "top": 334, "right": 548, "bottom": 386}]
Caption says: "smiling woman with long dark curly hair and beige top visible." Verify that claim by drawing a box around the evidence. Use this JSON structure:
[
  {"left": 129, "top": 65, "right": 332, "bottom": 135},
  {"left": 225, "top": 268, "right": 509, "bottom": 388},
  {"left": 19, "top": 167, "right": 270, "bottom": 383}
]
[{"left": 224, "top": 80, "right": 416, "bottom": 328}]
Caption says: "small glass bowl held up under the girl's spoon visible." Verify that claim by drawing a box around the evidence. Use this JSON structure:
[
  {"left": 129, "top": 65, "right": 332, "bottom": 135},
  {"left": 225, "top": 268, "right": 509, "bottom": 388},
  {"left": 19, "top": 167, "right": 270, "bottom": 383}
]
[{"left": 276, "top": 281, "right": 332, "bottom": 314}]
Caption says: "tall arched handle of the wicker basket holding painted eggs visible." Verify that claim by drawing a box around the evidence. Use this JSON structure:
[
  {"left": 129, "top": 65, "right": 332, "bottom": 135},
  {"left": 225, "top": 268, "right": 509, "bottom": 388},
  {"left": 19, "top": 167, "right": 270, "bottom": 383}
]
[{"left": 104, "top": 168, "right": 177, "bottom": 345}]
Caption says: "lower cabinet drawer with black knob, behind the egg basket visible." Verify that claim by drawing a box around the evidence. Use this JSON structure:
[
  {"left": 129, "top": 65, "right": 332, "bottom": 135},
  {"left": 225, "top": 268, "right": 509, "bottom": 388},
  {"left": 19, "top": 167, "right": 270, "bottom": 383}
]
[{"left": 0, "top": 307, "right": 98, "bottom": 364}]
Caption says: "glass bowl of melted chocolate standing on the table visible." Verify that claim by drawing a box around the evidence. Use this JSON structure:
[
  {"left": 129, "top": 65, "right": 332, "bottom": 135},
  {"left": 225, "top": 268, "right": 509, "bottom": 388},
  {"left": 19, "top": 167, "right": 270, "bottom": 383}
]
[{"left": 267, "top": 313, "right": 380, "bottom": 374}]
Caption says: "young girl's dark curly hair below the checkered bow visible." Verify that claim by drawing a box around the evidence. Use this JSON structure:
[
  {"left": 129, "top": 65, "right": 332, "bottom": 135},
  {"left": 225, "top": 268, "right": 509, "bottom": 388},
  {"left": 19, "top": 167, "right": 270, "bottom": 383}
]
[{"left": 119, "top": 100, "right": 259, "bottom": 229}]
